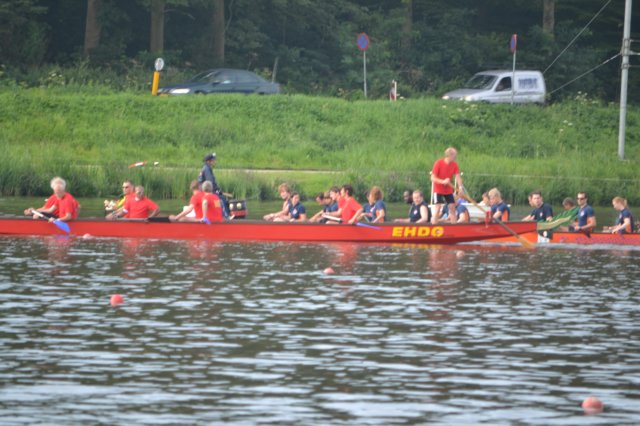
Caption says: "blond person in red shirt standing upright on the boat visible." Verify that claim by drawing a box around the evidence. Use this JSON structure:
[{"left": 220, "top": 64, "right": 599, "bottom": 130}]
[{"left": 431, "top": 147, "right": 464, "bottom": 224}]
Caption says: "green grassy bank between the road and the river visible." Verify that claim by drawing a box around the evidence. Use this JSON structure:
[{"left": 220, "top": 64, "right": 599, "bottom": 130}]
[{"left": 0, "top": 88, "right": 640, "bottom": 204}]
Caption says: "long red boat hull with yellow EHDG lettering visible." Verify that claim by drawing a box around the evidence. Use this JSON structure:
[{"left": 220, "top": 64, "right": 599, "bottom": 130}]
[{"left": 0, "top": 218, "right": 536, "bottom": 244}]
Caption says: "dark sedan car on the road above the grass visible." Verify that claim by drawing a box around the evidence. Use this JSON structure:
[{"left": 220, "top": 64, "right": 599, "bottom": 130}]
[{"left": 158, "top": 68, "right": 280, "bottom": 95}]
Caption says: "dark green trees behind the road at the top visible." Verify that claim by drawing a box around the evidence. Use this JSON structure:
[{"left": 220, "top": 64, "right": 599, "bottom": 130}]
[{"left": 0, "top": 0, "right": 640, "bottom": 101}]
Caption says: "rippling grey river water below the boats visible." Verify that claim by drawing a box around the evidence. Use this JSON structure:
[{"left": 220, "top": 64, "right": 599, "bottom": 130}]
[{"left": 0, "top": 237, "right": 640, "bottom": 425}]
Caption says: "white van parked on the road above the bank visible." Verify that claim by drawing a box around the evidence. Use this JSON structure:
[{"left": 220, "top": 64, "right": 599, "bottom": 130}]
[{"left": 442, "top": 70, "right": 547, "bottom": 104}]
